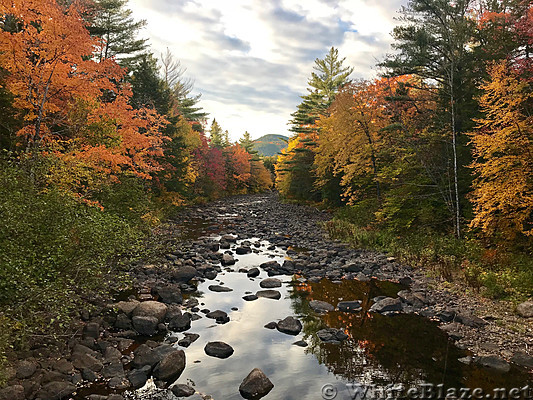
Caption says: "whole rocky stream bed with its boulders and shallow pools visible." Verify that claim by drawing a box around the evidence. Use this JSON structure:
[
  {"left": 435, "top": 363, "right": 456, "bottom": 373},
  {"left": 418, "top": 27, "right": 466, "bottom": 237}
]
[{"left": 0, "top": 193, "right": 533, "bottom": 400}]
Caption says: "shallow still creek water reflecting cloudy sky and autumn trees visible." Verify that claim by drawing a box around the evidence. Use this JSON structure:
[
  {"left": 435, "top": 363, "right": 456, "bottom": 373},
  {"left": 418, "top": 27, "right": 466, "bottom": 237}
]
[{"left": 80, "top": 239, "right": 530, "bottom": 400}]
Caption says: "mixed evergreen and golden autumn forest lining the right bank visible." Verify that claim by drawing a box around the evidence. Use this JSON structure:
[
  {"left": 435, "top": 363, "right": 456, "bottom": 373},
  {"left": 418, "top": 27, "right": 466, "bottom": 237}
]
[{"left": 276, "top": 0, "right": 533, "bottom": 297}]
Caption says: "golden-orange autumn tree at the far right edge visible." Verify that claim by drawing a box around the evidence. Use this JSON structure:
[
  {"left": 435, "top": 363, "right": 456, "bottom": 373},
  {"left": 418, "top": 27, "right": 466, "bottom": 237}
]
[{"left": 470, "top": 61, "right": 533, "bottom": 240}]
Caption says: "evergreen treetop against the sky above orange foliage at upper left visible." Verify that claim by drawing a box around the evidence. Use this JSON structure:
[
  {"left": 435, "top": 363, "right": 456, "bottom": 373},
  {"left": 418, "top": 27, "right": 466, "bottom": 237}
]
[{"left": 88, "top": 0, "right": 148, "bottom": 65}]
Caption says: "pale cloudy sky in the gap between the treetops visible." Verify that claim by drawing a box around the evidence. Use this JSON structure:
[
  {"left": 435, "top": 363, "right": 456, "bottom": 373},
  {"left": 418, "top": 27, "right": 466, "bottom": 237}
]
[{"left": 129, "top": 0, "right": 407, "bottom": 140}]
